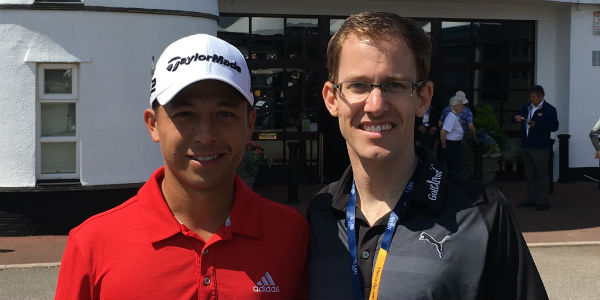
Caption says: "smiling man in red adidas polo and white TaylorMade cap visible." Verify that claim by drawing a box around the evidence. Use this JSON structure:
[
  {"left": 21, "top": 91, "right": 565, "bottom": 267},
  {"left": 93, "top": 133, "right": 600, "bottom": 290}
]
[{"left": 55, "top": 34, "right": 308, "bottom": 299}]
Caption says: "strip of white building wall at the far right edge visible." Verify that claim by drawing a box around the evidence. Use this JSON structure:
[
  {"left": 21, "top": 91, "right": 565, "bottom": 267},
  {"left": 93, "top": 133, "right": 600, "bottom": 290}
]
[{"left": 569, "top": 4, "right": 600, "bottom": 167}]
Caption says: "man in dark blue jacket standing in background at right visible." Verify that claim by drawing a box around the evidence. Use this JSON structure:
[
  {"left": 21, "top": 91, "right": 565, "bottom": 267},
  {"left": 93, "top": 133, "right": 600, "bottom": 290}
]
[{"left": 514, "top": 85, "right": 558, "bottom": 210}]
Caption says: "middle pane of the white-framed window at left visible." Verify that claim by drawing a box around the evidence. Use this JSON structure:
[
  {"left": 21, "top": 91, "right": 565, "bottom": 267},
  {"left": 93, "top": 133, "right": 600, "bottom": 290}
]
[{"left": 41, "top": 103, "right": 75, "bottom": 137}]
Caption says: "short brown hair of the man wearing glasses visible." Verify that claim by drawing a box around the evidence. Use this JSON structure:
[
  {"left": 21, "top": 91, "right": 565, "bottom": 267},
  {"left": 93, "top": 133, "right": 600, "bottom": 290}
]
[{"left": 327, "top": 12, "right": 432, "bottom": 83}]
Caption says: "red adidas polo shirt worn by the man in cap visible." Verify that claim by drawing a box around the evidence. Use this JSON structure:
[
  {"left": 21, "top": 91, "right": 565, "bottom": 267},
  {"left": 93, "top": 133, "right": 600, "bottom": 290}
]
[{"left": 55, "top": 168, "right": 308, "bottom": 299}]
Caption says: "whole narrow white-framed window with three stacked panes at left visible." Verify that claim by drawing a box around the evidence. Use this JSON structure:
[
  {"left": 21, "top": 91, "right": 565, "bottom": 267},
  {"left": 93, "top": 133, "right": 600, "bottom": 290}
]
[{"left": 37, "top": 64, "right": 79, "bottom": 180}]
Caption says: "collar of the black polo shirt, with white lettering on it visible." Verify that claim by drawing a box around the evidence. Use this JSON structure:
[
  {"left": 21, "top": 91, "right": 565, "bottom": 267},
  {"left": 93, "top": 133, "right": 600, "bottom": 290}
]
[{"left": 331, "top": 148, "right": 449, "bottom": 213}]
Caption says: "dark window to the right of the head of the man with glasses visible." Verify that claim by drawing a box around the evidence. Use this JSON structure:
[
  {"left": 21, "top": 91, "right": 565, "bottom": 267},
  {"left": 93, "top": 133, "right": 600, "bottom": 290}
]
[{"left": 432, "top": 20, "right": 535, "bottom": 137}]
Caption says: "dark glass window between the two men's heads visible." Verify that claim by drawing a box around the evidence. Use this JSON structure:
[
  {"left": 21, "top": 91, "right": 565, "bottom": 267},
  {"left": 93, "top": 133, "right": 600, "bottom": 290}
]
[{"left": 218, "top": 15, "right": 326, "bottom": 181}]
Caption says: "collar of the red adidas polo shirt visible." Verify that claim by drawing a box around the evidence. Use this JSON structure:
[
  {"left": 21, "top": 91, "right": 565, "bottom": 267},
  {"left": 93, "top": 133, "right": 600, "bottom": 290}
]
[{"left": 138, "top": 167, "right": 262, "bottom": 243}]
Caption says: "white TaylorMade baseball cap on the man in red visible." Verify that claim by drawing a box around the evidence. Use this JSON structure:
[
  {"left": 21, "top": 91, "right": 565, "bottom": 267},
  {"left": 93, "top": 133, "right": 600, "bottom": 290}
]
[{"left": 150, "top": 34, "right": 254, "bottom": 106}]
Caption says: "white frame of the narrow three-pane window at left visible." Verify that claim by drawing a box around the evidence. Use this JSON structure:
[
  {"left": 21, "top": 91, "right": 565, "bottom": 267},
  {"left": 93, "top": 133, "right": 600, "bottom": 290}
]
[{"left": 36, "top": 63, "right": 81, "bottom": 180}]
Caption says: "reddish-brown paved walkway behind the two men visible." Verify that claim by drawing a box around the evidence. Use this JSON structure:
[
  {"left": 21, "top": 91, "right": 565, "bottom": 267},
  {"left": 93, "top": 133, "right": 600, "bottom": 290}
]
[{"left": 0, "top": 181, "right": 600, "bottom": 266}]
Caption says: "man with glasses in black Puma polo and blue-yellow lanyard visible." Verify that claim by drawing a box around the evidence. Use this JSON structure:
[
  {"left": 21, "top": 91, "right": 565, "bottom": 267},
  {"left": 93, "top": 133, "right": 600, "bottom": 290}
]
[{"left": 308, "top": 13, "right": 547, "bottom": 299}]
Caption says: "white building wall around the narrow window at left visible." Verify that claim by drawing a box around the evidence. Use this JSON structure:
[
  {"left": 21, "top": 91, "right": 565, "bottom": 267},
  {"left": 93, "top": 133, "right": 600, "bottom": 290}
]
[{"left": 0, "top": 1, "right": 216, "bottom": 187}]
